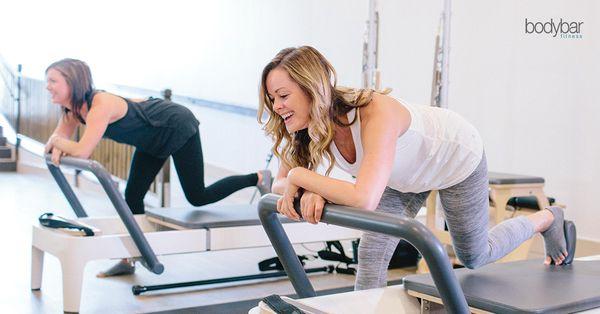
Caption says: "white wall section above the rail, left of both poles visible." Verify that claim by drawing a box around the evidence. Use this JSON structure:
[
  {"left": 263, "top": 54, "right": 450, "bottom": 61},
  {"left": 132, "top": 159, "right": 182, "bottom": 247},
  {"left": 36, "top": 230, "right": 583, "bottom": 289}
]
[{"left": 0, "top": 0, "right": 367, "bottom": 107}]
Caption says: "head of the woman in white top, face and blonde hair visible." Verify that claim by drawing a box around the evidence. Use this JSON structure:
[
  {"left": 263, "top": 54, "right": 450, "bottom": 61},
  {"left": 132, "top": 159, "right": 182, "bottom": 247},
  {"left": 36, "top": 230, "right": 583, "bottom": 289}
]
[{"left": 257, "top": 46, "right": 346, "bottom": 174}]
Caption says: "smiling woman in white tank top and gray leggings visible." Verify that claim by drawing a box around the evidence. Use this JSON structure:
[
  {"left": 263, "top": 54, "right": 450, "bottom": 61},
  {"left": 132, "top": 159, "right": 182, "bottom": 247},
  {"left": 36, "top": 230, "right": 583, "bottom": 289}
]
[{"left": 258, "top": 46, "right": 575, "bottom": 289}]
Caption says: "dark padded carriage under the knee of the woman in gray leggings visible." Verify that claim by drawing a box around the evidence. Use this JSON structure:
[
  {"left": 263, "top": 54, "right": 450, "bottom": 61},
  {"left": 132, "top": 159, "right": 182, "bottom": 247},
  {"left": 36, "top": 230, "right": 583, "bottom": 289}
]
[{"left": 404, "top": 260, "right": 600, "bottom": 313}]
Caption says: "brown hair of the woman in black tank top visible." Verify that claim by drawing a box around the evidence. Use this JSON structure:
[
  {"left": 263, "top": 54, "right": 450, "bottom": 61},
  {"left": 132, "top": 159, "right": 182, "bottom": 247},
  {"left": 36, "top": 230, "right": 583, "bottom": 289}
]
[{"left": 46, "top": 58, "right": 95, "bottom": 124}]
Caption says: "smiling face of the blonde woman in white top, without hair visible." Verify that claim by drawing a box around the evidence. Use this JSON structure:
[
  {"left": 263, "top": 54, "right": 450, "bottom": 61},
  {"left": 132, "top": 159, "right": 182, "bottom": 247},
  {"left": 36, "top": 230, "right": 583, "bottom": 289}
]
[{"left": 266, "top": 67, "right": 311, "bottom": 133}]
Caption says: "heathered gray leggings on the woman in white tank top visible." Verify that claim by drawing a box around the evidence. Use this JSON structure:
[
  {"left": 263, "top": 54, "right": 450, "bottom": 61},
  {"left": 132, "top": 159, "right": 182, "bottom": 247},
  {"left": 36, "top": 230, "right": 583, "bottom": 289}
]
[{"left": 355, "top": 154, "right": 534, "bottom": 290}]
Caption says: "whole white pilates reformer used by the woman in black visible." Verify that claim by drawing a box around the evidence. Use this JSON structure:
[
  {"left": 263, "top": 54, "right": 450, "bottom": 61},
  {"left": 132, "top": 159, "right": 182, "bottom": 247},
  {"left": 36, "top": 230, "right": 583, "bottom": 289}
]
[{"left": 31, "top": 156, "right": 360, "bottom": 312}]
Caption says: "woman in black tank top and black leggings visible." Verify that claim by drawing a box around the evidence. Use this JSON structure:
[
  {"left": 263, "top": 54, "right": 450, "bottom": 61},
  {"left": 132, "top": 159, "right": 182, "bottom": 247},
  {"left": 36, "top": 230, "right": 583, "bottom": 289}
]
[{"left": 45, "top": 59, "right": 271, "bottom": 214}]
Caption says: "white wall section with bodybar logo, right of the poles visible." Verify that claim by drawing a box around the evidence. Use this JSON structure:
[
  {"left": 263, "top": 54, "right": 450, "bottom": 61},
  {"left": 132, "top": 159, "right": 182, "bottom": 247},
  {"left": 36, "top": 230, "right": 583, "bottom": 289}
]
[{"left": 449, "top": 1, "right": 600, "bottom": 240}]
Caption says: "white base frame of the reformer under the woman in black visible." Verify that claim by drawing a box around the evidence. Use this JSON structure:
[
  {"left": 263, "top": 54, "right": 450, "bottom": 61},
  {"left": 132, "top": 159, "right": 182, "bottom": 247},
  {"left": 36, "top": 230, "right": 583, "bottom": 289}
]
[{"left": 31, "top": 215, "right": 361, "bottom": 312}]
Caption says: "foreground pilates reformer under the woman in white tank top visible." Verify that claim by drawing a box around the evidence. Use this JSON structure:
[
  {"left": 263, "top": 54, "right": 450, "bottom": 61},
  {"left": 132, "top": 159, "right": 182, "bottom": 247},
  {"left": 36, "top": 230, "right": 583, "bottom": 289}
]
[{"left": 250, "top": 194, "right": 600, "bottom": 314}]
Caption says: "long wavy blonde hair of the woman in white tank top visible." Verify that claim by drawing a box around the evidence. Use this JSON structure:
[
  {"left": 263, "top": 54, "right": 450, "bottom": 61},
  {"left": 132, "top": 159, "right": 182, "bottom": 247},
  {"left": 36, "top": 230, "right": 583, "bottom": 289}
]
[{"left": 257, "top": 46, "right": 389, "bottom": 175}]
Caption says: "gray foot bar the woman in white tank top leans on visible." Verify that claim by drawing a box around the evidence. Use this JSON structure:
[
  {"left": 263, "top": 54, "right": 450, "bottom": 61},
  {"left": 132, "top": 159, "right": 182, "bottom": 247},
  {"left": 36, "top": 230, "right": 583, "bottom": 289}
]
[{"left": 258, "top": 194, "right": 469, "bottom": 313}]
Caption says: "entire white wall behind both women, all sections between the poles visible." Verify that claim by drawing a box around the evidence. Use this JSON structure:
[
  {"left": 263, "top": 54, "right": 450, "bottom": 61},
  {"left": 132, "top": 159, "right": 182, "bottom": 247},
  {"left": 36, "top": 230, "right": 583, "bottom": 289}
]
[{"left": 0, "top": 0, "right": 600, "bottom": 240}]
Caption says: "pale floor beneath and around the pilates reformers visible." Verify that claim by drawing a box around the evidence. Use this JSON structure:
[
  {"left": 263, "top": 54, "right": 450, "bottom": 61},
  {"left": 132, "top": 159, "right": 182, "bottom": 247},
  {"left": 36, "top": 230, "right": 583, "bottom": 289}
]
[{"left": 0, "top": 150, "right": 600, "bottom": 313}]
